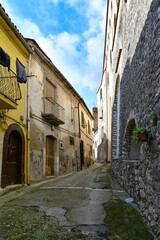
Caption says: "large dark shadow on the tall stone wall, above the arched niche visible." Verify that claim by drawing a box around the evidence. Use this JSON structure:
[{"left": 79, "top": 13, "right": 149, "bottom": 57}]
[{"left": 119, "top": 0, "right": 160, "bottom": 157}]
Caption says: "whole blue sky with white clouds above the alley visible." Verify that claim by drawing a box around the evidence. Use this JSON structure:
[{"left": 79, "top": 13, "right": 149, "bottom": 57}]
[{"left": 0, "top": 0, "right": 107, "bottom": 110}]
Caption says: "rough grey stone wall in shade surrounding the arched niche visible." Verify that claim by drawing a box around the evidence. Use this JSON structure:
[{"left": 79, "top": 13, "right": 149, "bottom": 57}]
[{"left": 112, "top": 0, "right": 160, "bottom": 239}]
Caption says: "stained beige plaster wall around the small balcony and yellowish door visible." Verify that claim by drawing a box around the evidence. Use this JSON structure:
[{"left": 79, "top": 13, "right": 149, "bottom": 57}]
[{"left": 29, "top": 41, "right": 80, "bottom": 181}]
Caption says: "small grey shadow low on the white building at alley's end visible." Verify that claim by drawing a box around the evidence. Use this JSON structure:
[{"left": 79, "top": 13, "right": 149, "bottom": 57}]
[{"left": 97, "top": 134, "right": 108, "bottom": 163}]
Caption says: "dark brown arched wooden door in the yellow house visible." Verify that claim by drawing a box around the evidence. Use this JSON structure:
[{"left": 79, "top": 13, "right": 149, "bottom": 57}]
[{"left": 1, "top": 124, "right": 25, "bottom": 188}]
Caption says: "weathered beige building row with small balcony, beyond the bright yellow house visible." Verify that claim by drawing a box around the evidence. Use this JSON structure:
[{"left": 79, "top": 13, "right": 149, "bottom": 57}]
[{"left": 26, "top": 39, "right": 92, "bottom": 182}]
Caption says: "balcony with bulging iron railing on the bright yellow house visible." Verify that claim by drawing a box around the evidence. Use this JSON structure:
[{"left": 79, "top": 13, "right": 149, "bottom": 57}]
[{"left": 0, "top": 65, "right": 22, "bottom": 109}]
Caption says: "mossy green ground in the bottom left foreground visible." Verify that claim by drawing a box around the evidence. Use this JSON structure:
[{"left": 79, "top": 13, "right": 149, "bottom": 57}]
[{"left": 0, "top": 207, "right": 85, "bottom": 240}]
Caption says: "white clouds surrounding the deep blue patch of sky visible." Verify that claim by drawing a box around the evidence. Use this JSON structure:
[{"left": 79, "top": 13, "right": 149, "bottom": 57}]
[{"left": 1, "top": 0, "right": 106, "bottom": 99}]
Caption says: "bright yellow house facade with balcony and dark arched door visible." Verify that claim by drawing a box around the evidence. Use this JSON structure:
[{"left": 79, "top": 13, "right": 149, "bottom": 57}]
[{"left": 0, "top": 5, "right": 31, "bottom": 188}]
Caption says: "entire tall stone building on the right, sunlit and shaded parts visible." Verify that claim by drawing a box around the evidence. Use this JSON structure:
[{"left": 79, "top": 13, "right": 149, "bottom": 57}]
[{"left": 98, "top": 0, "right": 160, "bottom": 239}]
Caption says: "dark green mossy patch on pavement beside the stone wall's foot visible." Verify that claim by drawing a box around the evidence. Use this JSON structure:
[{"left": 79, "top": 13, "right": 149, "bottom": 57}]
[{"left": 104, "top": 195, "right": 154, "bottom": 240}]
